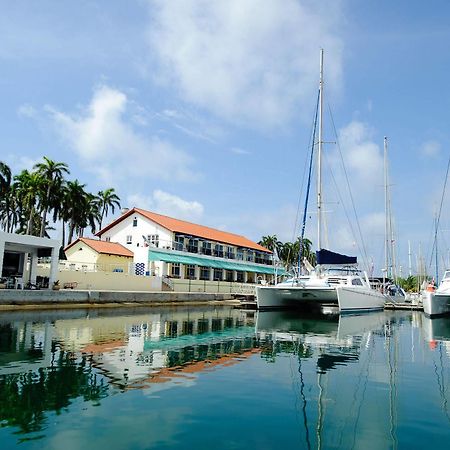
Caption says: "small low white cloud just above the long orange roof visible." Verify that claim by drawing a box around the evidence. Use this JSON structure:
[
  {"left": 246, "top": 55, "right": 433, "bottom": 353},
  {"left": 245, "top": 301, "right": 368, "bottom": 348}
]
[{"left": 127, "top": 189, "right": 204, "bottom": 222}]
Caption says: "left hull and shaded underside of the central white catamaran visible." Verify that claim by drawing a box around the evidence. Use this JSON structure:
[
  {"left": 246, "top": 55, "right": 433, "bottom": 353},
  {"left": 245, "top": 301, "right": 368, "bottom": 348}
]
[{"left": 256, "top": 286, "right": 337, "bottom": 309}]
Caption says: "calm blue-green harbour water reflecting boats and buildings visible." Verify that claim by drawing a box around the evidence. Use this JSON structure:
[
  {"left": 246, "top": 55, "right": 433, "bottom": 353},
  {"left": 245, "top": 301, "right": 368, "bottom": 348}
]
[{"left": 0, "top": 308, "right": 450, "bottom": 450}]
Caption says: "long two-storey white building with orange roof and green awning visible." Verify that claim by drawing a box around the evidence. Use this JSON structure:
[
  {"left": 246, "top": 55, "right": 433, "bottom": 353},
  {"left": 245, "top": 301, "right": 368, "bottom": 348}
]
[{"left": 97, "top": 208, "right": 275, "bottom": 283}]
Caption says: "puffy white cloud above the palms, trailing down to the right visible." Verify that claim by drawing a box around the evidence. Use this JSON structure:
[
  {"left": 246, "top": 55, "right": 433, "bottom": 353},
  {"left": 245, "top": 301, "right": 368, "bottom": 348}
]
[{"left": 47, "top": 86, "right": 198, "bottom": 183}]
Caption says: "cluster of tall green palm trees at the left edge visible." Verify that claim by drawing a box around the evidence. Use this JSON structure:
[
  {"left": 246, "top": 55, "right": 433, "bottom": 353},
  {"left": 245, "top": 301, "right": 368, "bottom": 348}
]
[{"left": 0, "top": 156, "right": 120, "bottom": 246}]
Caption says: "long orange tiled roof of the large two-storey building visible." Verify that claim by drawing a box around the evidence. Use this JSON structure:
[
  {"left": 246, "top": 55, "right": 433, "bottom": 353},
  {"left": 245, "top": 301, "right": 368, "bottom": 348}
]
[{"left": 96, "top": 208, "right": 272, "bottom": 253}]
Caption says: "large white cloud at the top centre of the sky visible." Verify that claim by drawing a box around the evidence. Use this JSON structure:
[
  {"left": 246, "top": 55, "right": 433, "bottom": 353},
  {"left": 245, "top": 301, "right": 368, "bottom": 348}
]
[{"left": 148, "top": 0, "right": 342, "bottom": 126}]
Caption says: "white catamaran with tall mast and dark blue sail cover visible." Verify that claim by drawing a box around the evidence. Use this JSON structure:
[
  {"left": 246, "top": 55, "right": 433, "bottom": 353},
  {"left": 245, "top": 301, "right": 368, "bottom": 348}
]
[{"left": 256, "top": 50, "right": 385, "bottom": 312}]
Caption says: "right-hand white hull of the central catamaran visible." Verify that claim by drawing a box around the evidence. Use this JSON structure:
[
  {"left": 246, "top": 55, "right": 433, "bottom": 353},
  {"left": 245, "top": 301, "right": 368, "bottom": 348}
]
[{"left": 336, "top": 286, "right": 386, "bottom": 313}]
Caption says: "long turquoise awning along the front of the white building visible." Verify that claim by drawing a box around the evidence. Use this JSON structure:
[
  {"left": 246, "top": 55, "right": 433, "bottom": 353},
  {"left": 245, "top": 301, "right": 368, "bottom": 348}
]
[{"left": 148, "top": 249, "right": 285, "bottom": 275}]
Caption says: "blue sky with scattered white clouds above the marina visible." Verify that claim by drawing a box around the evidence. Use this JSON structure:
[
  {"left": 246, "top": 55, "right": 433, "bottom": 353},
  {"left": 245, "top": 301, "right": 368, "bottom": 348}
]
[{"left": 0, "top": 0, "right": 450, "bottom": 276}]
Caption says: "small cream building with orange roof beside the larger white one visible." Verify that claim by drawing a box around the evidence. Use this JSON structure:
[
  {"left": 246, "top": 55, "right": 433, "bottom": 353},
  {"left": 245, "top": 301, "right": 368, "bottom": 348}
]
[{"left": 64, "top": 237, "right": 133, "bottom": 273}]
